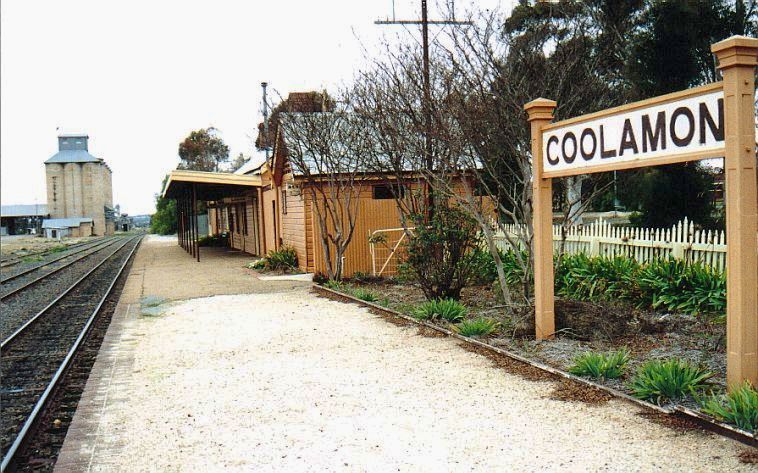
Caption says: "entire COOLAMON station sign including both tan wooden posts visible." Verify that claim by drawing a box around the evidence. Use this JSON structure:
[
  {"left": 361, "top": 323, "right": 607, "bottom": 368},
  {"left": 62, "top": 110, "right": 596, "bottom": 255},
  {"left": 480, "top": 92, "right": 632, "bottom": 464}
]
[{"left": 524, "top": 36, "right": 758, "bottom": 388}]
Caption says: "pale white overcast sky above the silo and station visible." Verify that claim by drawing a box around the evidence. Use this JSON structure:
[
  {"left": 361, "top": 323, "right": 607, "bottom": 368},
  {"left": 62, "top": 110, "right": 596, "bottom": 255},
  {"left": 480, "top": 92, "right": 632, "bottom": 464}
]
[{"left": 0, "top": 0, "right": 512, "bottom": 215}]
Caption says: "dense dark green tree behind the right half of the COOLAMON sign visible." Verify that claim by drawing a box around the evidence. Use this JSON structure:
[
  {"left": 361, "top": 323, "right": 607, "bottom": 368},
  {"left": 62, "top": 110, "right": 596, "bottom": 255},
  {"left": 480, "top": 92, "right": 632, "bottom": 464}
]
[{"left": 619, "top": 0, "right": 756, "bottom": 227}]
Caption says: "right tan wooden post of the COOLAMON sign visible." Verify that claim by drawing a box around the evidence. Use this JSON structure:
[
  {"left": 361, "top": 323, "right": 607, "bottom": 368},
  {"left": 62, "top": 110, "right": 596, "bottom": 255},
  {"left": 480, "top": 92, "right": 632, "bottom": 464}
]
[{"left": 711, "top": 36, "right": 758, "bottom": 389}]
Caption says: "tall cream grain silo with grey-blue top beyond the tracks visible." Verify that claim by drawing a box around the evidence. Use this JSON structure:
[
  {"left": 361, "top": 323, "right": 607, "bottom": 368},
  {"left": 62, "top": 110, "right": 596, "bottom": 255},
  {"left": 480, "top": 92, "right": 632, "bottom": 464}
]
[{"left": 45, "top": 134, "right": 115, "bottom": 236}]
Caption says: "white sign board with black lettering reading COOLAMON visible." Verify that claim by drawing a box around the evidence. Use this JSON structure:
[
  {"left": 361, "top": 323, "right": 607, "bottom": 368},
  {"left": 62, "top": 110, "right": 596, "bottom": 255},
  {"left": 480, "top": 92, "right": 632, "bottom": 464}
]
[{"left": 542, "top": 90, "right": 724, "bottom": 174}]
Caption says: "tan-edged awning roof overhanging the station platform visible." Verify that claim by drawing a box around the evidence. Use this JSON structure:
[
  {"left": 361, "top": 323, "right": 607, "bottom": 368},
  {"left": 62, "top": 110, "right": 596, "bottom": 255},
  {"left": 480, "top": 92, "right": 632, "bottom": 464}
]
[{"left": 163, "top": 170, "right": 261, "bottom": 201}]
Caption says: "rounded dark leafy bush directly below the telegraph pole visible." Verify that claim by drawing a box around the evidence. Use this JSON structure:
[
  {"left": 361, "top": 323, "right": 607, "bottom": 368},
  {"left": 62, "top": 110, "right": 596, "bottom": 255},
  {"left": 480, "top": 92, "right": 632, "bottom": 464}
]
[{"left": 405, "top": 202, "right": 479, "bottom": 300}]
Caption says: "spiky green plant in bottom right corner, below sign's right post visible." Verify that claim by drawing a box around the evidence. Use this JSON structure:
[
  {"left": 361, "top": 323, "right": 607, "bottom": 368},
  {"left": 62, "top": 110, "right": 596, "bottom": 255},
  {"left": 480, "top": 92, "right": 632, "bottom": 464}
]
[{"left": 701, "top": 381, "right": 758, "bottom": 432}]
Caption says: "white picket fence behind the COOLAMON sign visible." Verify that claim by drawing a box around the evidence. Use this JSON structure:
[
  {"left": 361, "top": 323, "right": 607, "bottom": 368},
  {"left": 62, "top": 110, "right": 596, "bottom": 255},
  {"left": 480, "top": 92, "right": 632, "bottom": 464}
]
[{"left": 495, "top": 219, "right": 726, "bottom": 271}]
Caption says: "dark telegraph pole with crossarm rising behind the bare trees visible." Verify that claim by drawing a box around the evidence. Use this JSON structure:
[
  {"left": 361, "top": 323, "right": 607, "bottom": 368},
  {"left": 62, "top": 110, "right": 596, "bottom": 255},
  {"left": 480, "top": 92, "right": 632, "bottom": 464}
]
[{"left": 374, "top": 0, "right": 472, "bottom": 217}]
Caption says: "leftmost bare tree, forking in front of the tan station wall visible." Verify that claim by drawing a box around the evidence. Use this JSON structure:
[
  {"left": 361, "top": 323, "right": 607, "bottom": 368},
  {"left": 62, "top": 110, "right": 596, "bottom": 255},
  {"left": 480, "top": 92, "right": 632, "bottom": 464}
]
[{"left": 280, "top": 106, "right": 370, "bottom": 280}]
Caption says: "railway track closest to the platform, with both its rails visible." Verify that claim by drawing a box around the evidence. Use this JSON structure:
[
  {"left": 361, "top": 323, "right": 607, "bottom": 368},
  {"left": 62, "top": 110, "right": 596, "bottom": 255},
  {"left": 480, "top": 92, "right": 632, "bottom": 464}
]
[{"left": 0, "top": 236, "right": 141, "bottom": 472}]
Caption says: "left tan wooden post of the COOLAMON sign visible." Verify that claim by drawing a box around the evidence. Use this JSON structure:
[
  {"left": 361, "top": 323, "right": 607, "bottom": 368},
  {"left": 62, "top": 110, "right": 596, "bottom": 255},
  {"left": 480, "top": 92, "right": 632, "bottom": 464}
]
[{"left": 524, "top": 98, "right": 556, "bottom": 340}]
